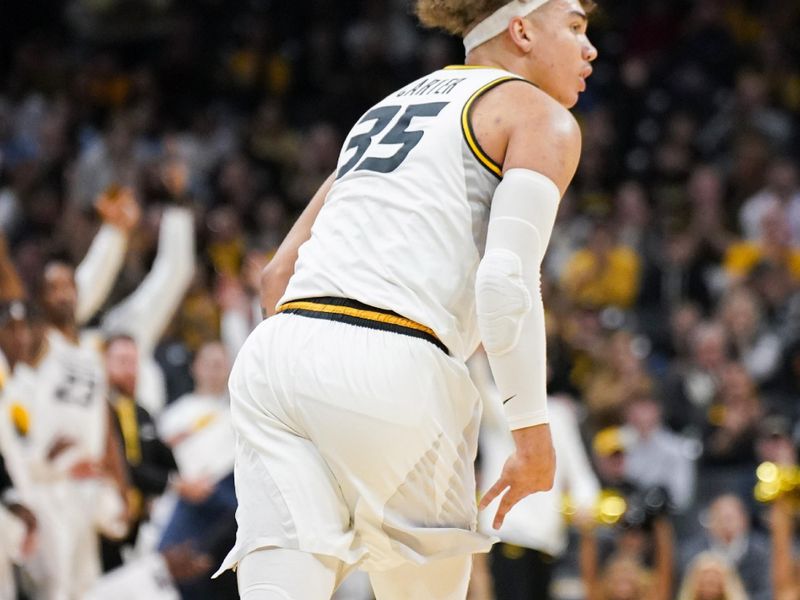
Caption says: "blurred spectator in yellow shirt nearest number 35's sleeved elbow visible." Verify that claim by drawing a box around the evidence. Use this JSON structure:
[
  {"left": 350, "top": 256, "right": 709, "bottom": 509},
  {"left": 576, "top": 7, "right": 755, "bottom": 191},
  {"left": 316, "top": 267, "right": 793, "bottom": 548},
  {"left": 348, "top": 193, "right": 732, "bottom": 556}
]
[{"left": 561, "top": 221, "right": 642, "bottom": 308}]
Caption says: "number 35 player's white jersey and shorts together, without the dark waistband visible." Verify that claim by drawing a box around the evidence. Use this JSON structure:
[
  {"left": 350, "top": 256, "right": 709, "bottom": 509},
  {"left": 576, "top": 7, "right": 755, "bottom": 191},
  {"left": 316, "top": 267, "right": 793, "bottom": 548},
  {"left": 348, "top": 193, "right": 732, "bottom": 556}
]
[{"left": 222, "top": 67, "right": 536, "bottom": 573}]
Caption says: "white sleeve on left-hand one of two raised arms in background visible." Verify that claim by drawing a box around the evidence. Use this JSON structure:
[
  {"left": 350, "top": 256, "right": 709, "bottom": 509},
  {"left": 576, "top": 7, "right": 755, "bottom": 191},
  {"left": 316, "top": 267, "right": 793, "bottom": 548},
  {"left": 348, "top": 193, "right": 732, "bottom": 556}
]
[{"left": 75, "top": 224, "right": 128, "bottom": 325}]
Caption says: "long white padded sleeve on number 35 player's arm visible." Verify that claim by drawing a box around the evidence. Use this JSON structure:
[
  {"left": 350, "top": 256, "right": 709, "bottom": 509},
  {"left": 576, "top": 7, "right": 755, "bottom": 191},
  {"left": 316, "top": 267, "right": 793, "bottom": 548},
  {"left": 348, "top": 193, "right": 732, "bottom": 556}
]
[{"left": 475, "top": 169, "right": 561, "bottom": 430}]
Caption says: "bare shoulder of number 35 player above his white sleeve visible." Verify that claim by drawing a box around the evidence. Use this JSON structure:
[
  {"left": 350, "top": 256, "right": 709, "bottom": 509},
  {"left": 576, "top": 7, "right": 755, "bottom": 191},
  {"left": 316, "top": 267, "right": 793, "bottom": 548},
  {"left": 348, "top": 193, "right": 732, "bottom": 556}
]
[{"left": 475, "top": 80, "right": 581, "bottom": 193}]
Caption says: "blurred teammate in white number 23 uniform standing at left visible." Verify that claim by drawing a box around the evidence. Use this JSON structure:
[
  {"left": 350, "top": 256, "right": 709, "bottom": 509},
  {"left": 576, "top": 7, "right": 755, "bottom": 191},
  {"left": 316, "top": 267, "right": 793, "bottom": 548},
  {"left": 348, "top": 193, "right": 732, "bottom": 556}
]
[{"left": 4, "top": 274, "right": 127, "bottom": 600}]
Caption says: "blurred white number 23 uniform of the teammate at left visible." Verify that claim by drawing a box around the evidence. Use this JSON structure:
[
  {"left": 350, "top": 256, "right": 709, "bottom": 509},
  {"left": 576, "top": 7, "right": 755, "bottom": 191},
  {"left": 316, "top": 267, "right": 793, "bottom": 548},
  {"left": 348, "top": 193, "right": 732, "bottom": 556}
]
[{"left": 2, "top": 330, "right": 125, "bottom": 600}]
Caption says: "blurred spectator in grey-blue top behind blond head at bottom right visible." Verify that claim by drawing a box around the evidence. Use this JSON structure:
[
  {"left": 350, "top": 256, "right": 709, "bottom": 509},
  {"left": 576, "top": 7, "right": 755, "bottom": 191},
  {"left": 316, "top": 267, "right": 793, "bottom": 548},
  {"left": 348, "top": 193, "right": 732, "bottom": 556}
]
[{"left": 680, "top": 494, "right": 772, "bottom": 600}]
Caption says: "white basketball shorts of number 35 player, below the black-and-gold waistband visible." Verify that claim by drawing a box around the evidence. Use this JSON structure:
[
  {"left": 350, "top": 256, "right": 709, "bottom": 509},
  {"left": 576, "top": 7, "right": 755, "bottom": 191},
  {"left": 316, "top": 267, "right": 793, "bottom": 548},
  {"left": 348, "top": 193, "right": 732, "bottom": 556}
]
[{"left": 222, "top": 314, "right": 493, "bottom": 571}]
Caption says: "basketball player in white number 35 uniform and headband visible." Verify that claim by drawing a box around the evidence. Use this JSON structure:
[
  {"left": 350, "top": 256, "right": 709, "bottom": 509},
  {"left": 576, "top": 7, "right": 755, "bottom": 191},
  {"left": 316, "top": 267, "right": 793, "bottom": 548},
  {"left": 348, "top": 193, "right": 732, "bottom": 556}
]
[{"left": 223, "top": 0, "right": 596, "bottom": 600}]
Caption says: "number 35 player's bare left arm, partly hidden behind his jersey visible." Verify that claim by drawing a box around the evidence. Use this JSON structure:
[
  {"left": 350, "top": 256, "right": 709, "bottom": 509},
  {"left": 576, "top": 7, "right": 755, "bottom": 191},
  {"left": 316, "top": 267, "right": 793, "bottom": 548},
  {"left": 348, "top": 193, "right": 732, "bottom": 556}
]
[{"left": 261, "top": 175, "right": 334, "bottom": 317}]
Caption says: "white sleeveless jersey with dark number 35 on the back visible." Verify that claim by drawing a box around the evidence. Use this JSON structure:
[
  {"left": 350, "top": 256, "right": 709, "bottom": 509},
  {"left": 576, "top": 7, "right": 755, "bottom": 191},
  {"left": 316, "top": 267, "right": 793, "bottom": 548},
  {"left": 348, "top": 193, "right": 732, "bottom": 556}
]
[{"left": 281, "top": 67, "right": 519, "bottom": 358}]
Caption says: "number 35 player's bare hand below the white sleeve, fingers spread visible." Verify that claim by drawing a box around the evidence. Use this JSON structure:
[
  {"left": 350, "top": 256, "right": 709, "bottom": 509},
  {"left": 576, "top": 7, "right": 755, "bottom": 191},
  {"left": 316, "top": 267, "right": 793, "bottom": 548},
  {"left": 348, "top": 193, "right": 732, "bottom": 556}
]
[{"left": 479, "top": 424, "right": 556, "bottom": 529}]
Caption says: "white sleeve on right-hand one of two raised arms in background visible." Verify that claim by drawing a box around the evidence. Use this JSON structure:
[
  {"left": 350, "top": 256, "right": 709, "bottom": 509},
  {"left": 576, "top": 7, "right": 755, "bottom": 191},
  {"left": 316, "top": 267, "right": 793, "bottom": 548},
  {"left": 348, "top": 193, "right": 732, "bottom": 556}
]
[{"left": 103, "top": 207, "right": 194, "bottom": 353}]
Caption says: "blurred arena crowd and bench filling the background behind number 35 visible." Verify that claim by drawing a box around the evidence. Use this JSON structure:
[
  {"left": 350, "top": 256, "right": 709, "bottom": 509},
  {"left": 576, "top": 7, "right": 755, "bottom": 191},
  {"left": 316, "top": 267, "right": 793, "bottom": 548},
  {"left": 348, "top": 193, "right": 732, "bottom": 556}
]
[{"left": 0, "top": 0, "right": 800, "bottom": 600}]
